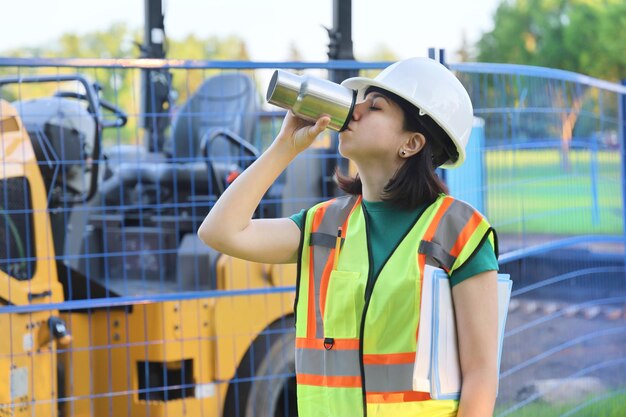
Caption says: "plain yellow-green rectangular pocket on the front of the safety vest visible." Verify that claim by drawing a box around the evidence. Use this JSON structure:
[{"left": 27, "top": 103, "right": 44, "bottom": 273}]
[{"left": 324, "top": 271, "right": 361, "bottom": 339}]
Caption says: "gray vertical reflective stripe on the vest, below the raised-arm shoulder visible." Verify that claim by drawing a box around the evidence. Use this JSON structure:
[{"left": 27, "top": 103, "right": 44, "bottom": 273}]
[{"left": 309, "top": 196, "right": 357, "bottom": 339}]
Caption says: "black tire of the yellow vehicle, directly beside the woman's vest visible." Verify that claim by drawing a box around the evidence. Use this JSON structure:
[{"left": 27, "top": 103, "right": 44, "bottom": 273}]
[{"left": 224, "top": 317, "right": 297, "bottom": 417}]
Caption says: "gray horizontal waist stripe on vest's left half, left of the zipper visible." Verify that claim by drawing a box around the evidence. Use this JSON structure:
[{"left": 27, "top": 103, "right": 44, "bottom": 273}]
[{"left": 296, "top": 348, "right": 361, "bottom": 377}]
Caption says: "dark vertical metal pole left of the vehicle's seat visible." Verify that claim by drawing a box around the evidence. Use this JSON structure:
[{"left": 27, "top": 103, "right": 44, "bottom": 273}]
[{"left": 141, "top": 0, "right": 172, "bottom": 152}]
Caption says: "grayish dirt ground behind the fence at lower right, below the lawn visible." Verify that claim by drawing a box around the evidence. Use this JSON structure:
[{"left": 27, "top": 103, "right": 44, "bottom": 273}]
[{"left": 498, "top": 299, "right": 626, "bottom": 404}]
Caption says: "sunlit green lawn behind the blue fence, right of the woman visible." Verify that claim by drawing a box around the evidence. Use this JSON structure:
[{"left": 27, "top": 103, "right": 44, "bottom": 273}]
[{"left": 485, "top": 149, "right": 623, "bottom": 235}]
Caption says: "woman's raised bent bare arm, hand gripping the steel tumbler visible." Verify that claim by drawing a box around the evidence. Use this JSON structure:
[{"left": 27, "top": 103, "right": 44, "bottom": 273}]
[{"left": 198, "top": 112, "right": 330, "bottom": 263}]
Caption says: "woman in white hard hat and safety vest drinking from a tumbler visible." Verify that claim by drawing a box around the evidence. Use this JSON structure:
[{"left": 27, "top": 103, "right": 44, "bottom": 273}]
[{"left": 198, "top": 58, "right": 497, "bottom": 417}]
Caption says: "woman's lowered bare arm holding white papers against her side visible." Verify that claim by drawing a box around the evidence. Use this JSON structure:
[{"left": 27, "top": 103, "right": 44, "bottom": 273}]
[{"left": 452, "top": 271, "right": 498, "bottom": 417}]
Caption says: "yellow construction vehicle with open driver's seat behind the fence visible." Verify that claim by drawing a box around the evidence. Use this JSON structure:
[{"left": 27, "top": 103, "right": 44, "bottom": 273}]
[{"left": 0, "top": 73, "right": 310, "bottom": 417}]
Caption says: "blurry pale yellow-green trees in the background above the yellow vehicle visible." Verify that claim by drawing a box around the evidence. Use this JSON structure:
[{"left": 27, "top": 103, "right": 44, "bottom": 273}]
[{"left": 0, "top": 23, "right": 249, "bottom": 144}]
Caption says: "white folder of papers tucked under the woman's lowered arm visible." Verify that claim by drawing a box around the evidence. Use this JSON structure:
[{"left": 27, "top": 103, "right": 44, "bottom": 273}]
[{"left": 413, "top": 265, "right": 512, "bottom": 400}]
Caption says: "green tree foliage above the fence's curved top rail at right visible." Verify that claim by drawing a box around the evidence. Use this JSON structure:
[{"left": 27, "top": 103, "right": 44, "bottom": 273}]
[{"left": 477, "top": 0, "right": 626, "bottom": 81}]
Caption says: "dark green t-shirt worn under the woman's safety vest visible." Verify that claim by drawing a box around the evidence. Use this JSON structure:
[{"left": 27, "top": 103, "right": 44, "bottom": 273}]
[{"left": 290, "top": 200, "right": 498, "bottom": 287}]
